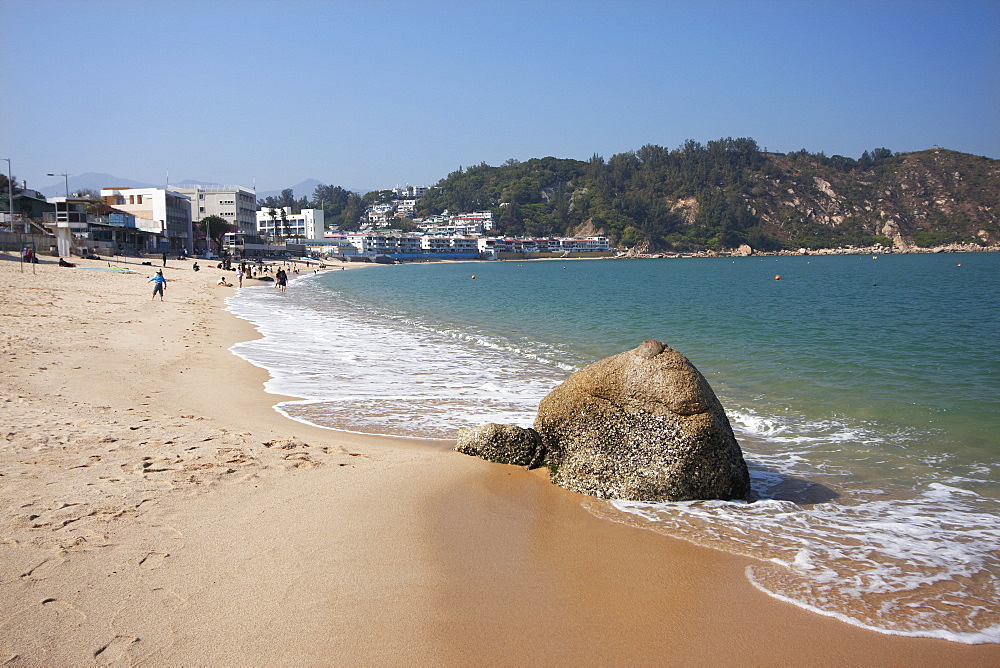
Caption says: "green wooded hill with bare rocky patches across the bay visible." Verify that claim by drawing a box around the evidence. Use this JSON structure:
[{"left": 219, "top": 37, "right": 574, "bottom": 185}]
[{"left": 416, "top": 138, "right": 1000, "bottom": 252}]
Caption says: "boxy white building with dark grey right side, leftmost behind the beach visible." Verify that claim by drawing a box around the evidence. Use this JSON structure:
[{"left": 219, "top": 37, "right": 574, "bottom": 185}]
[{"left": 101, "top": 188, "right": 194, "bottom": 253}]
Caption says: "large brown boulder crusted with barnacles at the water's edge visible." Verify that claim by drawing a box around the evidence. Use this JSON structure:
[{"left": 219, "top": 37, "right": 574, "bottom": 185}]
[{"left": 534, "top": 341, "right": 750, "bottom": 501}]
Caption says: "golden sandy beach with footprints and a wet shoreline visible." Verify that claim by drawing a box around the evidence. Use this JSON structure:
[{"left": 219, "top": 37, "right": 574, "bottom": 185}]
[{"left": 0, "top": 254, "right": 1000, "bottom": 666}]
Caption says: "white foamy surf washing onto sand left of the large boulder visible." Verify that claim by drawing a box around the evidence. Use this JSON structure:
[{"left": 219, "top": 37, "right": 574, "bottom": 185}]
[{"left": 229, "top": 274, "right": 566, "bottom": 438}]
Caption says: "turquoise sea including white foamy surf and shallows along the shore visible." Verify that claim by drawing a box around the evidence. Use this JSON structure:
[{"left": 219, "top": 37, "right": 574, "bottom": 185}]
[{"left": 230, "top": 253, "right": 1000, "bottom": 642}]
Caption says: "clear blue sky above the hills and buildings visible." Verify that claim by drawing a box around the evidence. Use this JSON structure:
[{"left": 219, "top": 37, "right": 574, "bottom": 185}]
[{"left": 0, "top": 0, "right": 1000, "bottom": 196}]
